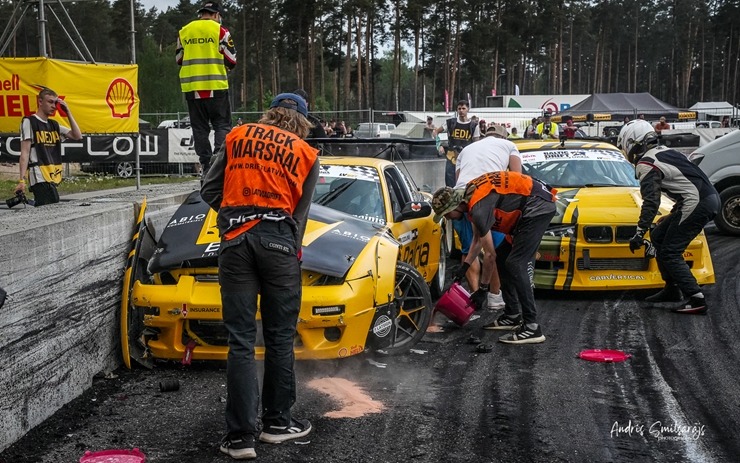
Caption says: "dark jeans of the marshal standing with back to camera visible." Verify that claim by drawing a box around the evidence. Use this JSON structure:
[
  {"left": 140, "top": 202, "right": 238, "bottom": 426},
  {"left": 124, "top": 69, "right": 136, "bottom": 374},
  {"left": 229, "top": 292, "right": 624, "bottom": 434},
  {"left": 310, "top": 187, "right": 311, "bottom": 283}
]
[{"left": 218, "top": 222, "right": 301, "bottom": 436}]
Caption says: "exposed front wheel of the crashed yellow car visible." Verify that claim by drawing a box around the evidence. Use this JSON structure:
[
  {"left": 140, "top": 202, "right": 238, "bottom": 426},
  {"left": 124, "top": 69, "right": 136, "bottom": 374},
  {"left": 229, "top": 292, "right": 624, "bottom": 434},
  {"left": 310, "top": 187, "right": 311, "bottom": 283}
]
[{"left": 378, "top": 262, "right": 432, "bottom": 355}]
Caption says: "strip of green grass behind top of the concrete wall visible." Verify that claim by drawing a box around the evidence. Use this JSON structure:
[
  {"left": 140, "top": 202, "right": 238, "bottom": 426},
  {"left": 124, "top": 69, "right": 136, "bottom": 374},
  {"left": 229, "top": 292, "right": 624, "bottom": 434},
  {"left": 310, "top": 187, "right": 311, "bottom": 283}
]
[{"left": 0, "top": 175, "right": 198, "bottom": 201}]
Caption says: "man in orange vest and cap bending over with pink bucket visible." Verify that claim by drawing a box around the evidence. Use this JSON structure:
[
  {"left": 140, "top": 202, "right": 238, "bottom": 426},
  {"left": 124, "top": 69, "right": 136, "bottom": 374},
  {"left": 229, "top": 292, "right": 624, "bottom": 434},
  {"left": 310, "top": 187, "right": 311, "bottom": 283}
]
[{"left": 432, "top": 171, "right": 555, "bottom": 344}]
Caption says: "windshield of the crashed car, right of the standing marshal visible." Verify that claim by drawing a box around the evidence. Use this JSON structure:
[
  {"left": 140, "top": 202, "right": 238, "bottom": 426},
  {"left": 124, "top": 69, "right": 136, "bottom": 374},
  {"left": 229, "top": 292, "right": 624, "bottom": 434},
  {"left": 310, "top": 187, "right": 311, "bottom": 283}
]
[{"left": 311, "top": 164, "right": 385, "bottom": 224}]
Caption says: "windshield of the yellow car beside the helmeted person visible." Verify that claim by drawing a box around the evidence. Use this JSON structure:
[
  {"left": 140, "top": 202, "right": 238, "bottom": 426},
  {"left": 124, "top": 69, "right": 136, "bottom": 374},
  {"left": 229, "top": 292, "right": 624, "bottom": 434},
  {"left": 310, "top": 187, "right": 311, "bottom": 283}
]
[{"left": 522, "top": 149, "right": 639, "bottom": 188}]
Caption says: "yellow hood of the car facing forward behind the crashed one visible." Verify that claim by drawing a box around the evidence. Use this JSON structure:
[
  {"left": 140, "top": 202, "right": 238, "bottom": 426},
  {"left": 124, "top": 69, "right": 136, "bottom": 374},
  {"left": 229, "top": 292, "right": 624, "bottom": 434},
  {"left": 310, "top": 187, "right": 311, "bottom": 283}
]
[{"left": 552, "top": 187, "right": 671, "bottom": 224}]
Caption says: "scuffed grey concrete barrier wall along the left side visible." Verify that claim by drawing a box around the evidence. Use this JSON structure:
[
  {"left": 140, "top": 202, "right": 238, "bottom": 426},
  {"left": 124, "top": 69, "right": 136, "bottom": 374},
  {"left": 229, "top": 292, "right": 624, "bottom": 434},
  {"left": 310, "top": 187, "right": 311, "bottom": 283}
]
[{"left": 0, "top": 181, "right": 198, "bottom": 451}]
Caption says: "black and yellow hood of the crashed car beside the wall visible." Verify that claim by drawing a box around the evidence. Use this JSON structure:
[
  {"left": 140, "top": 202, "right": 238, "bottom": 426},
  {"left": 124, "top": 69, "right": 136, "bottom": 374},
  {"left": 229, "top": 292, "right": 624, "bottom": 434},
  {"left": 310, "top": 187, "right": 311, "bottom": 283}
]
[{"left": 148, "top": 191, "right": 386, "bottom": 277}]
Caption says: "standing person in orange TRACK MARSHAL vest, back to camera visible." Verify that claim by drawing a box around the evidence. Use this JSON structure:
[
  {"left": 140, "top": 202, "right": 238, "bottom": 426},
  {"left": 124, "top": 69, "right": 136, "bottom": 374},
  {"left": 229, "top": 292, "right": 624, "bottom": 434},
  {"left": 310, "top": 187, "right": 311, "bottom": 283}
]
[{"left": 201, "top": 93, "right": 319, "bottom": 459}]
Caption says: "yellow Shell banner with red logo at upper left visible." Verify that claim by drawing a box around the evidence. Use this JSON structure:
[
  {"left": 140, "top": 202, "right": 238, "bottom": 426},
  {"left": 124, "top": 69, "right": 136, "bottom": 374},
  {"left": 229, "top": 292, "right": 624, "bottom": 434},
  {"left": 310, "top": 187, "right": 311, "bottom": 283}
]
[{"left": 0, "top": 58, "right": 139, "bottom": 135}]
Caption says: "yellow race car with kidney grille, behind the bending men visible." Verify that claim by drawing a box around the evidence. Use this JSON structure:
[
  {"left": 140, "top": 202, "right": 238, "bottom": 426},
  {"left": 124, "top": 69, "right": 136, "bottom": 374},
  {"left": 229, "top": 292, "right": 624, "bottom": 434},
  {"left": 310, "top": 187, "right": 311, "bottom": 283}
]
[{"left": 516, "top": 140, "right": 714, "bottom": 290}]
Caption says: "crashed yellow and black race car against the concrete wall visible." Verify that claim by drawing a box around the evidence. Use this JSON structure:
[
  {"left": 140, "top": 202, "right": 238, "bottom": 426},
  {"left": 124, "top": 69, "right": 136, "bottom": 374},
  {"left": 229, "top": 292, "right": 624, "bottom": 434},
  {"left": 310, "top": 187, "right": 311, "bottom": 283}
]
[{"left": 120, "top": 157, "right": 446, "bottom": 367}]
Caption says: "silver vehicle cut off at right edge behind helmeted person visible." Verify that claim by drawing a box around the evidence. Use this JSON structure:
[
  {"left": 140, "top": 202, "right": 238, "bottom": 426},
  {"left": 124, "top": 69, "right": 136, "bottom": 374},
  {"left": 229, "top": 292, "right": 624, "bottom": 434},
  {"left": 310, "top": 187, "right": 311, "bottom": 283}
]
[{"left": 689, "top": 130, "right": 740, "bottom": 236}]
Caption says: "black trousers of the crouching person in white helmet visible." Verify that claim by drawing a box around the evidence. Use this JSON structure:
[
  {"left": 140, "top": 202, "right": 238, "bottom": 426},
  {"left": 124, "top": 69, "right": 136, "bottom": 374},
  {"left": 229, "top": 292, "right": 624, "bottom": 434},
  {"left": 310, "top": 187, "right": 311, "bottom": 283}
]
[{"left": 650, "top": 195, "right": 720, "bottom": 296}]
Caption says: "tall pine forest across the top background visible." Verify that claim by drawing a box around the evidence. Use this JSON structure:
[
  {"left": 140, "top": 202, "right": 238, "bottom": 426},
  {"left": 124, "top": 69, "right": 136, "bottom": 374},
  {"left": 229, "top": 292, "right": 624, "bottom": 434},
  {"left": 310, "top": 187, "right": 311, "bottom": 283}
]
[{"left": 0, "top": 0, "right": 740, "bottom": 117}]
